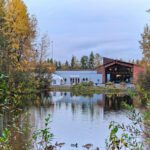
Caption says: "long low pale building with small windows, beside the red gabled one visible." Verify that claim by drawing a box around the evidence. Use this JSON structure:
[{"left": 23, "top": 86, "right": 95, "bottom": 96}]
[{"left": 53, "top": 70, "right": 102, "bottom": 85}]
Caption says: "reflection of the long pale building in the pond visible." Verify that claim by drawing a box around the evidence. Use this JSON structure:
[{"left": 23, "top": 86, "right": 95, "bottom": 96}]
[{"left": 51, "top": 92, "right": 104, "bottom": 119}]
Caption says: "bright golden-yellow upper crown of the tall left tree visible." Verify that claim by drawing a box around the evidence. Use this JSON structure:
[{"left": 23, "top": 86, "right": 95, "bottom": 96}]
[{"left": 5, "top": 0, "right": 30, "bottom": 36}]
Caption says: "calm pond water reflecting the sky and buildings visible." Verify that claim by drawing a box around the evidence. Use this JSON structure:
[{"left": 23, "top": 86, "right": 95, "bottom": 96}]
[{"left": 0, "top": 92, "right": 133, "bottom": 150}]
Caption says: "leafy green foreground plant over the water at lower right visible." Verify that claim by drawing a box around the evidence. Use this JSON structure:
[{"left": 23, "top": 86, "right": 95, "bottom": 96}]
[{"left": 106, "top": 109, "right": 145, "bottom": 150}]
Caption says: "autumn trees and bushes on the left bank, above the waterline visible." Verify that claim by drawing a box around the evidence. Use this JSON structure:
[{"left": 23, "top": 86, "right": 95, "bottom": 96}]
[{"left": 0, "top": 0, "right": 54, "bottom": 92}]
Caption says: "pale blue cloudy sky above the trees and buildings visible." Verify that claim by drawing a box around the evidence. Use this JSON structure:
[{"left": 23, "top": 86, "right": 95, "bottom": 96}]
[{"left": 24, "top": 0, "right": 150, "bottom": 62}]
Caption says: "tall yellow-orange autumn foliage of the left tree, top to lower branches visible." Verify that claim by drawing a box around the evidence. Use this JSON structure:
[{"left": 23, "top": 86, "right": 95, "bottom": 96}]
[{"left": 0, "top": 0, "right": 36, "bottom": 70}]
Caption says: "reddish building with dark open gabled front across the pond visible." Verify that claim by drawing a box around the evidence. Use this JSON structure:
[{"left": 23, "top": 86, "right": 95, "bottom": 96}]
[{"left": 96, "top": 58, "right": 144, "bottom": 83}]
